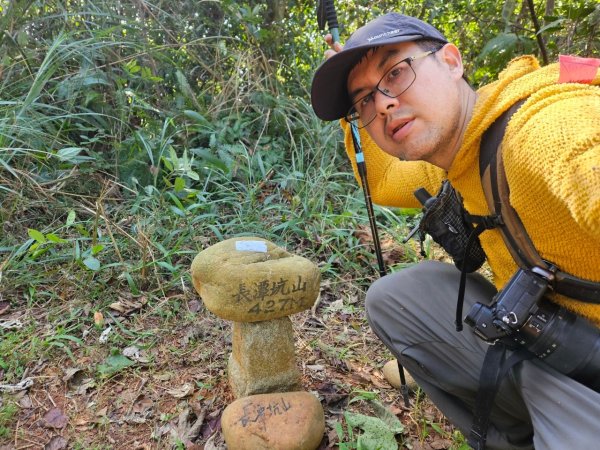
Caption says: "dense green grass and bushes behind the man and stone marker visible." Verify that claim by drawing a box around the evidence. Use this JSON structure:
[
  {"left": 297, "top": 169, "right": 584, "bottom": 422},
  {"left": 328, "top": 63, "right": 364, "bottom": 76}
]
[{"left": 0, "top": 0, "right": 600, "bottom": 448}]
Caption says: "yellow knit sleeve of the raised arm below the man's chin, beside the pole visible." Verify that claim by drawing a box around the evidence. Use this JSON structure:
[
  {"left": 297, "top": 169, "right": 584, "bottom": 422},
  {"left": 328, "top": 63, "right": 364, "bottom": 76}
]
[{"left": 340, "top": 120, "right": 446, "bottom": 208}]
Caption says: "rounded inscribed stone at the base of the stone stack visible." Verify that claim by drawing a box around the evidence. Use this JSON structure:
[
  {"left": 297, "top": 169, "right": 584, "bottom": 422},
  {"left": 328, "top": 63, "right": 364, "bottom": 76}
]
[{"left": 221, "top": 392, "right": 325, "bottom": 450}]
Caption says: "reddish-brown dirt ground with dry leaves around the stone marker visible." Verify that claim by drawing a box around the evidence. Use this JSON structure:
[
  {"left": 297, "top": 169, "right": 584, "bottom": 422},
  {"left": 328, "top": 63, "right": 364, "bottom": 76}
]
[{"left": 0, "top": 278, "right": 460, "bottom": 450}]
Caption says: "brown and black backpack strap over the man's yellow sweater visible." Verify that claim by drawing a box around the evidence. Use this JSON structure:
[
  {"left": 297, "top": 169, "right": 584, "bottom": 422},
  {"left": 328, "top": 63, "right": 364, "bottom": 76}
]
[{"left": 479, "top": 100, "right": 600, "bottom": 303}]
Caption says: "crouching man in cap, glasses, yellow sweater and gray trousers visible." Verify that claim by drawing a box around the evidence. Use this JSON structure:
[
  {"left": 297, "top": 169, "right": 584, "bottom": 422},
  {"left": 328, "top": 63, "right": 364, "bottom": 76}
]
[{"left": 312, "top": 13, "right": 600, "bottom": 450}]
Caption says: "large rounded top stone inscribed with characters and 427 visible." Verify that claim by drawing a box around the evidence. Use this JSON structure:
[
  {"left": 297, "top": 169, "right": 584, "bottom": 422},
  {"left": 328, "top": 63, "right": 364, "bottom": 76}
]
[{"left": 191, "top": 237, "right": 321, "bottom": 322}]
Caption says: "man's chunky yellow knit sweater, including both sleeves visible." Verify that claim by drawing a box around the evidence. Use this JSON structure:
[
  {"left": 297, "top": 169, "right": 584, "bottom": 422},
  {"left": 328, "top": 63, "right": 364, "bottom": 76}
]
[{"left": 342, "top": 56, "right": 600, "bottom": 325}]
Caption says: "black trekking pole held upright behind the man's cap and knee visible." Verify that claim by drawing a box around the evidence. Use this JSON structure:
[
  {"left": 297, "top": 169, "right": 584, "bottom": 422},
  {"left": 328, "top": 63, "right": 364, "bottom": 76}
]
[{"left": 317, "top": 0, "right": 410, "bottom": 408}]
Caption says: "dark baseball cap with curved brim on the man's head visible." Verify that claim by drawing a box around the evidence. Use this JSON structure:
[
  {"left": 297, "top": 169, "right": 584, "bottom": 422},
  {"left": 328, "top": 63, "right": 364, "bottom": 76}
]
[{"left": 311, "top": 12, "right": 448, "bottom": 120}]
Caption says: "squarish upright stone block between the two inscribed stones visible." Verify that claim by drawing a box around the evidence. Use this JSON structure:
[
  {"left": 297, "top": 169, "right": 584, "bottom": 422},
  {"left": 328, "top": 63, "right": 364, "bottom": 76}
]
[{"left": 228, "top": 317, "right": 300, "bottom": 398}]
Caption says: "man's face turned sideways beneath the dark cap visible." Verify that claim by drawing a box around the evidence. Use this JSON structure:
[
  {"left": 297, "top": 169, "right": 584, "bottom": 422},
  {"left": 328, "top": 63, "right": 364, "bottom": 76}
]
[{"left": 347, "top": 42, "right": 466, "bottom": 169}]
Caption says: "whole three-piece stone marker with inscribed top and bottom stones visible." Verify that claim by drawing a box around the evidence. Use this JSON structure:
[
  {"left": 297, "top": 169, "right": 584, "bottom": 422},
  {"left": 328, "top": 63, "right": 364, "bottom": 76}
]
[{"left": 192, "top": 237, "right": 325, "bottom": 450}]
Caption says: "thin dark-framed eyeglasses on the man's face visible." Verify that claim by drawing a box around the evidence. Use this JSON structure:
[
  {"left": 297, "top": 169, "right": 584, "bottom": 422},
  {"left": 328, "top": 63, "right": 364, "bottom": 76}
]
[{"left": 345, "top": 48, "right": 440, "bottom": 128}]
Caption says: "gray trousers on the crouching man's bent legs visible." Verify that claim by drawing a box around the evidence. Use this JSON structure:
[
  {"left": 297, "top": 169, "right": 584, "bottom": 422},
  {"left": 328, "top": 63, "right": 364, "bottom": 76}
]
[{"left": 366, "top": 261, "right": 600, "bottom": 450}]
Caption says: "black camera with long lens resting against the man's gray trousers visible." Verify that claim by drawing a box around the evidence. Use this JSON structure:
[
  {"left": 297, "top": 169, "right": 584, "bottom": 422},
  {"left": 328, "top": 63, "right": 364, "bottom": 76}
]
[{"left": 464, "top": 268, "right": 600, "bottom": 390}]
